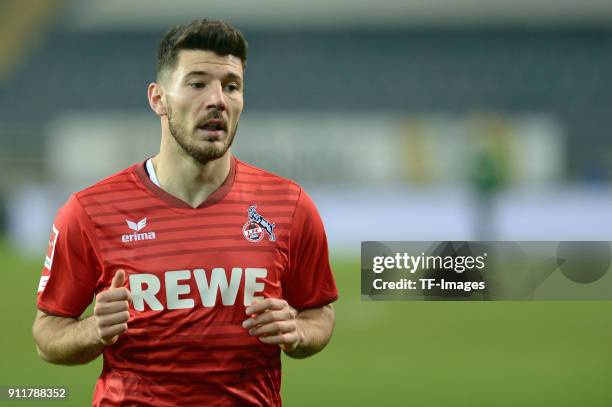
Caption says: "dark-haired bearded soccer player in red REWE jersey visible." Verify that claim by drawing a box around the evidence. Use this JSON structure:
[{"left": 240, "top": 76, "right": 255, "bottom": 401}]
[{"left": 33, "top": 20, "right": 338, "bottom": 406}]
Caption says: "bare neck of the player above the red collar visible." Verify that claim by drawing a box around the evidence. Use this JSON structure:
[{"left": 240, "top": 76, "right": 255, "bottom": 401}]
[{"left": 152, "top": 129, "right": 231, "bottom": 208}]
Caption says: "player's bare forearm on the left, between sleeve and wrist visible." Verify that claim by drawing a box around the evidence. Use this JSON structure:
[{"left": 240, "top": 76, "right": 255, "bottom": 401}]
[{"left": 32, "top": 312, "right": 104, "bottom": 365}]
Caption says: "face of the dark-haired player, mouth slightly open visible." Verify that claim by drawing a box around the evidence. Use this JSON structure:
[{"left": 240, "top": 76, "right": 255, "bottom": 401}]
[{"left": 162, "top": 50, "right": 243, "bottom": 164}]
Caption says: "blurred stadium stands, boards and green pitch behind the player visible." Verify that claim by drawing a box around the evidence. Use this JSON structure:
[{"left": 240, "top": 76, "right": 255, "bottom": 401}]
[{"left": 0, "top": 0, "right": 612, "bottom": 406}]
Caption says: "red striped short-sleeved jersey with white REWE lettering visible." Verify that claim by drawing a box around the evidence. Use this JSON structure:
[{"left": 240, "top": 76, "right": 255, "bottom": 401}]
[{"left": 38, "top": 158, "right": 338, "bottom": 406}]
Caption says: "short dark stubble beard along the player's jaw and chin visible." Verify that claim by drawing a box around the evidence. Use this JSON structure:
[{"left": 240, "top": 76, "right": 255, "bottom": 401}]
[{"left": 166, "top": 106, "right": 238, "bottom": 164}]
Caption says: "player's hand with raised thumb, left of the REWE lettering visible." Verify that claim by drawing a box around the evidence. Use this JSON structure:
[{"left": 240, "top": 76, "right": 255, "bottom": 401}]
[{"left": 94, "top": 269, "right": 132, "bottom": 345}]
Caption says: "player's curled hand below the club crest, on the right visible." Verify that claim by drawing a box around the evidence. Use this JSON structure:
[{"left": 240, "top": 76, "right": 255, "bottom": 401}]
[{"left": 242, "top": 298, "right": 302, "bottom": 352}]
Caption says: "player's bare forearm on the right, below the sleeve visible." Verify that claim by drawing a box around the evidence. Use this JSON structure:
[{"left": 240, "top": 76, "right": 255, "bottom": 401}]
[{"left": 285, "top": 304, "right": 335, "bottom": 359}]
